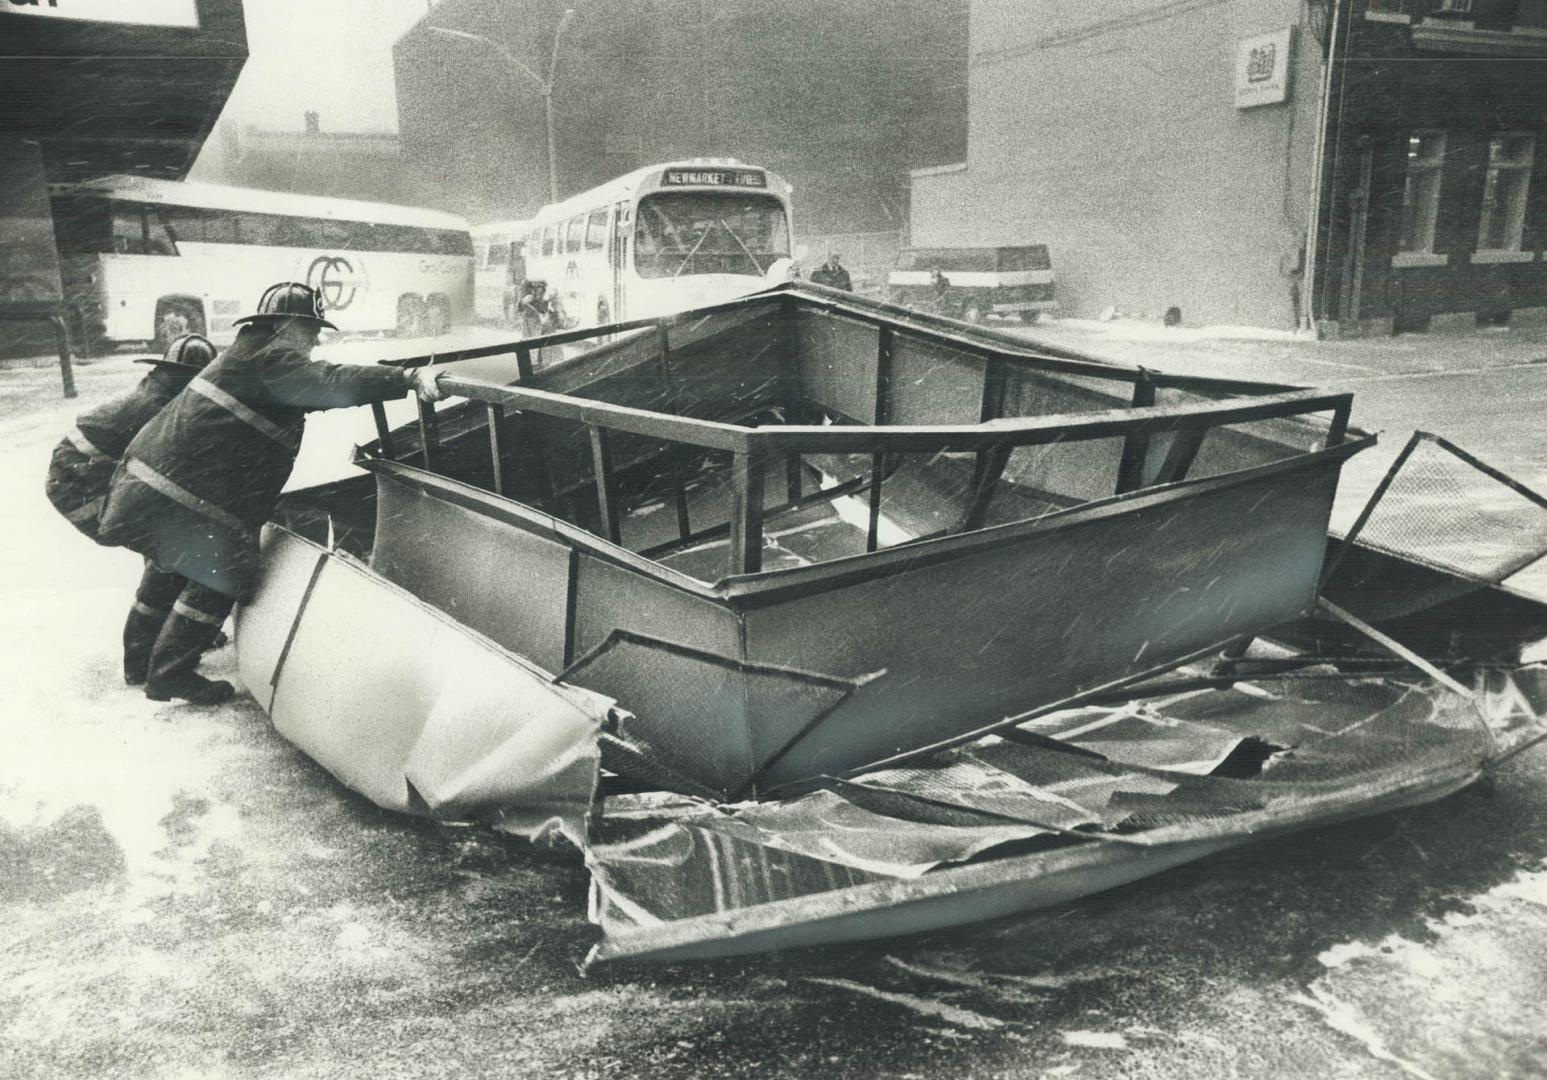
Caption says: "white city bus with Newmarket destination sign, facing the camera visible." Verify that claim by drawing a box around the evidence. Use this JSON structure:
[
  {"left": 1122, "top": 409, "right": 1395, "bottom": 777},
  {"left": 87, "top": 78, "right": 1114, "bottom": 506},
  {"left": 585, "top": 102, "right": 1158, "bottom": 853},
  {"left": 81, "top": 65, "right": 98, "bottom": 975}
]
[{"left": 526, "top": 158, "right": 792, "bottom": 326}]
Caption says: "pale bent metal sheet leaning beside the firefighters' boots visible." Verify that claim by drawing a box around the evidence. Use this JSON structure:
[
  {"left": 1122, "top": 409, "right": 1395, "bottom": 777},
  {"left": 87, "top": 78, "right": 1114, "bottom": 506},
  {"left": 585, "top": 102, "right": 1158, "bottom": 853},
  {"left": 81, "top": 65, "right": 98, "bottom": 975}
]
[{"left": 237, "top": 526, "right": 611, "bottom": 837}]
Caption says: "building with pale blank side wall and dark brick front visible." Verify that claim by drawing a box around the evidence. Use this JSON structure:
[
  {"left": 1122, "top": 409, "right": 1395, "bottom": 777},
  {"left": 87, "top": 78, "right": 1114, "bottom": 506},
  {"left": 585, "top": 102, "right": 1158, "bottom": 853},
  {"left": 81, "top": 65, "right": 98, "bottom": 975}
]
[{"left": 911, "top": 0, "right": 1547, "bottom": 334}]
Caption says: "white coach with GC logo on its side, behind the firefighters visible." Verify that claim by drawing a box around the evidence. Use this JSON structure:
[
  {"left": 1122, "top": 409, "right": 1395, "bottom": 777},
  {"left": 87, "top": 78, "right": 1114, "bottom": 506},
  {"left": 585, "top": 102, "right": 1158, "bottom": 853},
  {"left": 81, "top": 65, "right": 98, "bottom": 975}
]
[{"left": 50, "top": 176, "right": 473, "bottom": 348}]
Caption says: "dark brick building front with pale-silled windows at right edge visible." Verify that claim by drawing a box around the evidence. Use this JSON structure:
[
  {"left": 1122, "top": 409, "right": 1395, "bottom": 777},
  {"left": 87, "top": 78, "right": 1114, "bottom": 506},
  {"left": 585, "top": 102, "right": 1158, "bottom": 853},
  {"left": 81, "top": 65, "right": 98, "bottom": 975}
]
[{"left": 1316, "top": 0, "right": 1547, "bottom": 333}]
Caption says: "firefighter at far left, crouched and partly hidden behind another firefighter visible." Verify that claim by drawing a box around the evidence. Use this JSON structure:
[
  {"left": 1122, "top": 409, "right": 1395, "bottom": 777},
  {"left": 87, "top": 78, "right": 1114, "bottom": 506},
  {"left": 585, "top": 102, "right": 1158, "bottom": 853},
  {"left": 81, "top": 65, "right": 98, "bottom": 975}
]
[{"left": 43, "top": 334, "right": 215, "bottom": 685}]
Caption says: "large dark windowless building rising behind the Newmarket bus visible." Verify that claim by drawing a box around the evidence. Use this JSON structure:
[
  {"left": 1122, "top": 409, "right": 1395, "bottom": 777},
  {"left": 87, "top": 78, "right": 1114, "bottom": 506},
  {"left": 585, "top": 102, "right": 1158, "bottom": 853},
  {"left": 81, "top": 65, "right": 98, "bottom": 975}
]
[{"left": 394, "top": 0, "right": 968, "bottom": 234}]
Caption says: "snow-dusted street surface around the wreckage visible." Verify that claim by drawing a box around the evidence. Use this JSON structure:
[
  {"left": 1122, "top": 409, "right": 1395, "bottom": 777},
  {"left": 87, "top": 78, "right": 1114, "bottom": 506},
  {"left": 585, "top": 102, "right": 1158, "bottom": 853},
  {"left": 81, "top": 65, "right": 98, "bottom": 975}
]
[{"left": 0, "top": 331, "right": 1547, "bottom": 1080}]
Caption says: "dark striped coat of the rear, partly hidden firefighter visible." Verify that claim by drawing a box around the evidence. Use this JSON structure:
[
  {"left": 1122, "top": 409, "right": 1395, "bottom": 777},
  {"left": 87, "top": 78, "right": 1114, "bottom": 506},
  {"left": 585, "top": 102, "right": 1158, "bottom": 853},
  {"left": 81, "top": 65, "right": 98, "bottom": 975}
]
[{"left": 43, "top": 362, "right": 198, "bottom": 543}]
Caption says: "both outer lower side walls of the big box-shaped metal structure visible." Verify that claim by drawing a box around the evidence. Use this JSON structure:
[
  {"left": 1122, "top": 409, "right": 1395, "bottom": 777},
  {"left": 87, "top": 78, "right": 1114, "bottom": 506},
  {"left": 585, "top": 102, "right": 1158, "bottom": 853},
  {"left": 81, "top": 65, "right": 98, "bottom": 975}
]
[{"left": 355, "top": 436, "right": 1361, "bottom": 791}]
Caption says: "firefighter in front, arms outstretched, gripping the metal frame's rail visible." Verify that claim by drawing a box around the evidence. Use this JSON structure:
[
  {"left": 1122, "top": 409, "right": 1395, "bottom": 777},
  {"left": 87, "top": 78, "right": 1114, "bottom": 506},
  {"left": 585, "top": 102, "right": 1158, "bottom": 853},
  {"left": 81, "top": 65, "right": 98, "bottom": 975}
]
[{"left": 99, "top": 282, "right": 441, "bottom": 704}]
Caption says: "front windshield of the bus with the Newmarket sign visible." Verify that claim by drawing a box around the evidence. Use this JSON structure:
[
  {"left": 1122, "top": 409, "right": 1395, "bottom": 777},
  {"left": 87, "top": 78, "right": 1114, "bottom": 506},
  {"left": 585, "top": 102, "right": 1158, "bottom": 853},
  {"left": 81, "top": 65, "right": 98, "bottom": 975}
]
[{"left": 634, "top": 192, "right": 789, "bottom": 277}]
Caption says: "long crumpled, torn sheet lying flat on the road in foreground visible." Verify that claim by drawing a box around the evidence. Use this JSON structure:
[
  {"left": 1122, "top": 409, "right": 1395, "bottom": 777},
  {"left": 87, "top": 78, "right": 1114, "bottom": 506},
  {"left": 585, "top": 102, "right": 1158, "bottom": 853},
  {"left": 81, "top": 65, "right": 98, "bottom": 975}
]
[{"left": 588, "top": 675, "right": 1503, "bottom": 961}]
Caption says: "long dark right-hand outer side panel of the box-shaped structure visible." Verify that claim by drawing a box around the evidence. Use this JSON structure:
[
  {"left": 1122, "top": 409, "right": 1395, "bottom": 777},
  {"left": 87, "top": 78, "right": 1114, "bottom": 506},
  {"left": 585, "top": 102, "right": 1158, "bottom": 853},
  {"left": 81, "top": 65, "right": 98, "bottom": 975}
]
[{"left": 744, "top": 460, "right": 1340, "bottom": 784}]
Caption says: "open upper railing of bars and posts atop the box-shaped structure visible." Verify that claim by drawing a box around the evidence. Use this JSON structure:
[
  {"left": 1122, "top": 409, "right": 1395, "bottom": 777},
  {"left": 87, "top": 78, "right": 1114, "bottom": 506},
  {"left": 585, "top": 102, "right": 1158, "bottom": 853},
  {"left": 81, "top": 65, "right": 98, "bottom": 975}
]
[{"left": 376, "top": 285, "right": 1354, "bottom": 577}]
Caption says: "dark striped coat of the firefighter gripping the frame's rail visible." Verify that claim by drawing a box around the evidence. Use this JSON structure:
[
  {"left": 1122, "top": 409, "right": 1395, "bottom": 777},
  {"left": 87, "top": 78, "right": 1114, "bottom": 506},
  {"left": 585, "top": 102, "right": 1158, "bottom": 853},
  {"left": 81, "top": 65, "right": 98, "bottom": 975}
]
[{"left": 101, "top": 326, "right": 410, "bottom": 597}]
